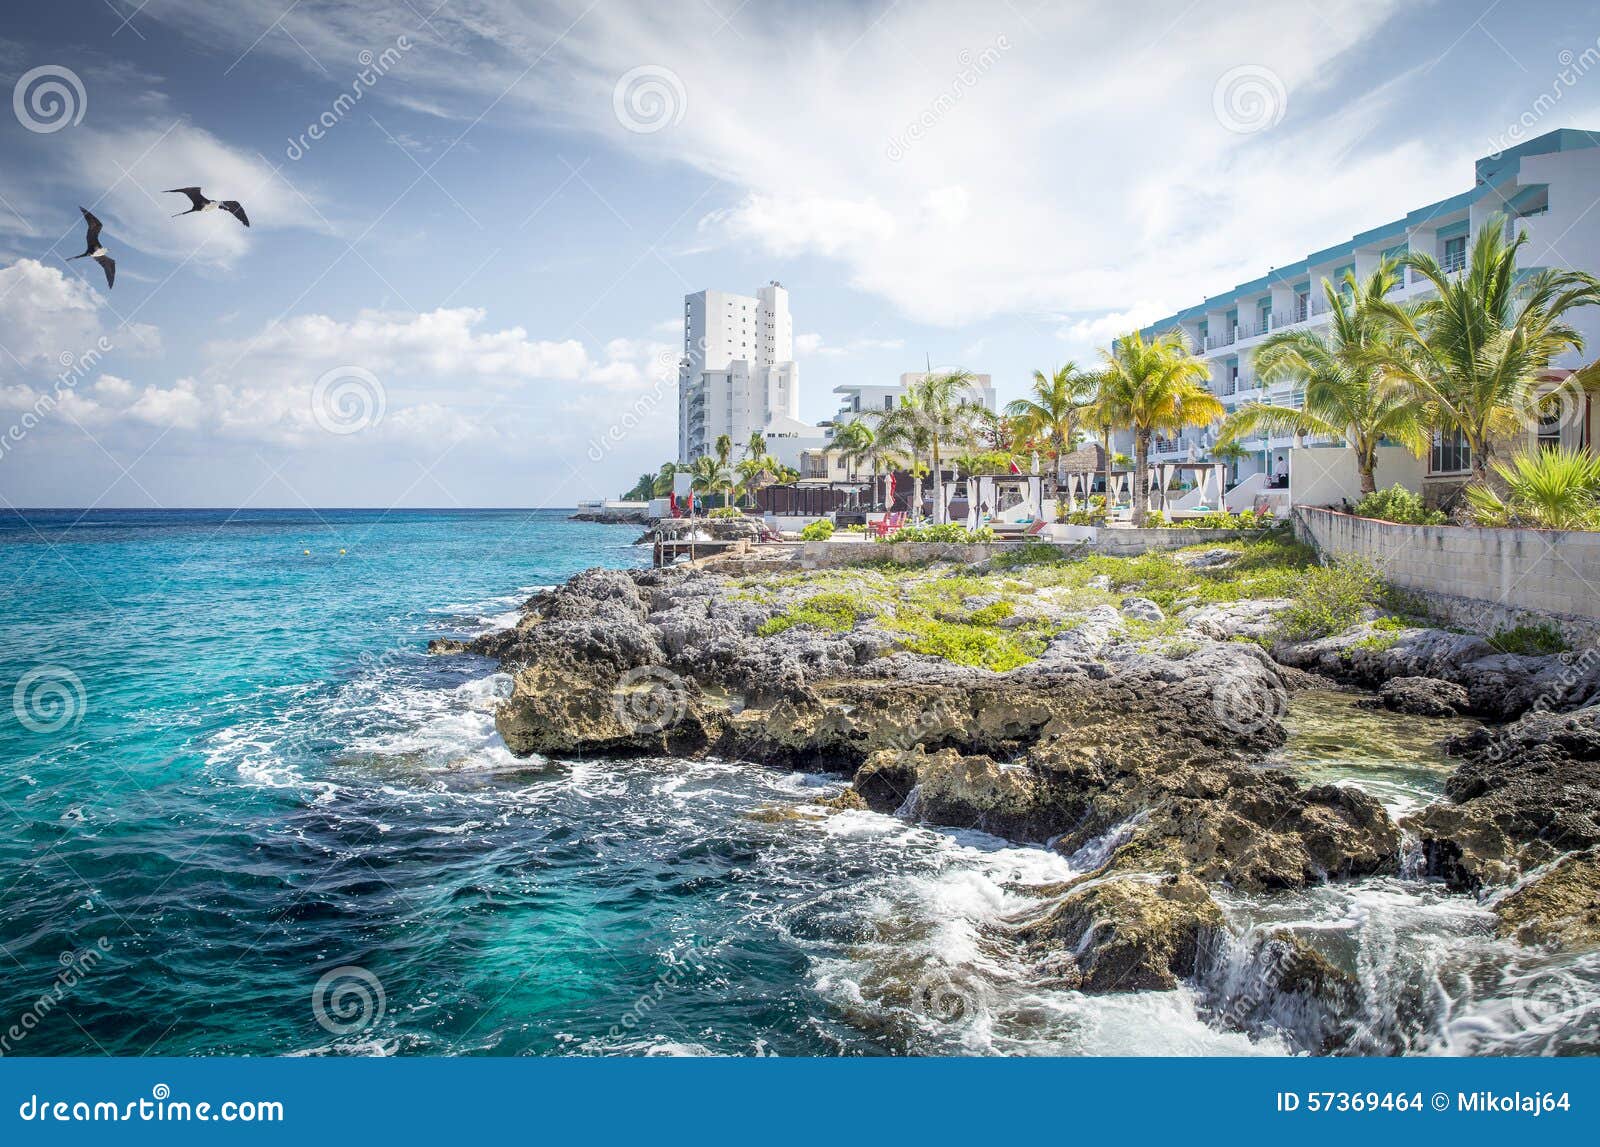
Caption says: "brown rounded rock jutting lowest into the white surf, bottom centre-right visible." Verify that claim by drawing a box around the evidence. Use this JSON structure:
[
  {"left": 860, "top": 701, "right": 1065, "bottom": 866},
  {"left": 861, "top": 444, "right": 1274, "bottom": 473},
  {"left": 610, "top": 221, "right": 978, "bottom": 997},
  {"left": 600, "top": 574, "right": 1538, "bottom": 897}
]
[{"left": 1016, "top": 875, "right": 1222, "bottom": 992}]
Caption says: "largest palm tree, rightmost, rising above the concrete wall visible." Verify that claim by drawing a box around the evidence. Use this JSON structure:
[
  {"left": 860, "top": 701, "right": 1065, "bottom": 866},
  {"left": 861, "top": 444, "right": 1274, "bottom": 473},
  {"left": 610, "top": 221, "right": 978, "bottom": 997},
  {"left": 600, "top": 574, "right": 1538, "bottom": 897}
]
[{"left": 1374, "top": 214, "right": 1600, "bottom": 486}]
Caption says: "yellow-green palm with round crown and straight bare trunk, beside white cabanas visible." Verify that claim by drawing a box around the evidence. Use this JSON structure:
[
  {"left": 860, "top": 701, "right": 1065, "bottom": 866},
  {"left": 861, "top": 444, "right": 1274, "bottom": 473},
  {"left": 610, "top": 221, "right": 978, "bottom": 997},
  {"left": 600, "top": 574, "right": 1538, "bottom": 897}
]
[{"left": 1090, "top": 331, "right": 1224, "bottom": 526}]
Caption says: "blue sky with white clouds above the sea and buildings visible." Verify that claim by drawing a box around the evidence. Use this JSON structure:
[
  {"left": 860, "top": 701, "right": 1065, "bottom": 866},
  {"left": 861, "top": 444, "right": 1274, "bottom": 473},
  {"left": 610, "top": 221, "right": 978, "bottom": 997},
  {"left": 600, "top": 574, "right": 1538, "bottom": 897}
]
[{"left": 0, "top": 0, "right": 1600, "bottom": 507}]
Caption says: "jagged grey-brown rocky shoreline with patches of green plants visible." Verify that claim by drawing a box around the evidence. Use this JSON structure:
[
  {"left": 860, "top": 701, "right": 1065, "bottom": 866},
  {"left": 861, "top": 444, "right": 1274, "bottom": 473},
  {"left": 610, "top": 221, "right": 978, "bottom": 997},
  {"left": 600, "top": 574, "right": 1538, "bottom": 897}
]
[{"left": 434, "top": 549, "right": 1600, "bottom": 1048}]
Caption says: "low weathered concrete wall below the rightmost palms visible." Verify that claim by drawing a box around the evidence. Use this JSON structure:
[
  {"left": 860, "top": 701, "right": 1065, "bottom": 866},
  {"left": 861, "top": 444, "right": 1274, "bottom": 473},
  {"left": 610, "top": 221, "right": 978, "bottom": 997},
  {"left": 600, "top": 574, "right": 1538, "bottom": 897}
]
[{"left": 1294, "top": 506, "right": 1600, "bottom": 643}]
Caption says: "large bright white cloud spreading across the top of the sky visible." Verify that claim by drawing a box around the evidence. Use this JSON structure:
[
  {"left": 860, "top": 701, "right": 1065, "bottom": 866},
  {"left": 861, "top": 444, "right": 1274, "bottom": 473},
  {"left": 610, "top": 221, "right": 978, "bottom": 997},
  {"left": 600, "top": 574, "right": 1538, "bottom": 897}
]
[{"left": 134, "top": 0, "right": 1462, "bottom": 333}]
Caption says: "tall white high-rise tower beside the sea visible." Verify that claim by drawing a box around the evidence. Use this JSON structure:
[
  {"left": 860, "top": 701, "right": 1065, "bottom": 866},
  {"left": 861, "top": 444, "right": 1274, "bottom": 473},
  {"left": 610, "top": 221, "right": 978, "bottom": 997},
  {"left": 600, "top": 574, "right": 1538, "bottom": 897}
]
[{"left": 678, "top": 280, "right": 824, "bottom": 466}]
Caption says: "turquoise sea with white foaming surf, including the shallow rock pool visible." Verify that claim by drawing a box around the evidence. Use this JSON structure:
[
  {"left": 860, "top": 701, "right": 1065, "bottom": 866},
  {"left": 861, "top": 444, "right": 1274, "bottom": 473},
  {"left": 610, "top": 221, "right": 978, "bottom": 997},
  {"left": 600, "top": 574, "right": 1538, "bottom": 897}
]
[{"left": 0, "top": 510, "right": 1600, "bottom": 1056}]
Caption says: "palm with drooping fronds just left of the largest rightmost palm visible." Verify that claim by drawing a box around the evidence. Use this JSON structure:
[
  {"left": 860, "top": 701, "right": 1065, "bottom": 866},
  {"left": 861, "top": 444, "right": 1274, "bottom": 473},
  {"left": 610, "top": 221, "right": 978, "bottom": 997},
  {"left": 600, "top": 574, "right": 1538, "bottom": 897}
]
[{"left": 1219, "top": 259, "right": 1429, "bottom": 496}]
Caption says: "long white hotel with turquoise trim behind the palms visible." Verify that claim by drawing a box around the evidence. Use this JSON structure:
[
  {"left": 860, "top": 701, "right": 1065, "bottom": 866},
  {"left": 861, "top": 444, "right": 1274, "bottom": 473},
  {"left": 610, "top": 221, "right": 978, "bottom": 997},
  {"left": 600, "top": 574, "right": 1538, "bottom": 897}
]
[{"left": 1114, "top": 130, "right": 1600, "bottom": 501}]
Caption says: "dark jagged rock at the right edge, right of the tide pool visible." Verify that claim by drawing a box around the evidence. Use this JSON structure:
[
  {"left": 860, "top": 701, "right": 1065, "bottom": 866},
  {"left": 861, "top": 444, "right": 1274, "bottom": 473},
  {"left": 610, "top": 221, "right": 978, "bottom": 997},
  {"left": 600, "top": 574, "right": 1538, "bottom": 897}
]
[{"left": 1406, "top": 705, "right": 1600, "bottom": 889}]
